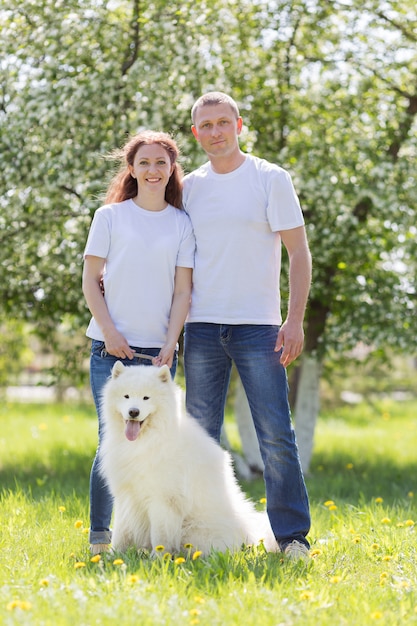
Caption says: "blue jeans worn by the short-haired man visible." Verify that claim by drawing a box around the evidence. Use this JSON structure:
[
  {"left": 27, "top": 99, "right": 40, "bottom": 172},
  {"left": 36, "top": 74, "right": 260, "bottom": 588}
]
[{"left": 184, "top": 322, "right": 311, "bottom": 550}]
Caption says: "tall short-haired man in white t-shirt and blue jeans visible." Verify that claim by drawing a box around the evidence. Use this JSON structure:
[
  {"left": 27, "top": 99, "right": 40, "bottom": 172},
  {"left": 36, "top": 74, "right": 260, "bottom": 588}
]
[{"left": 184, "top": 92, "right": 311, "bottom": 559}]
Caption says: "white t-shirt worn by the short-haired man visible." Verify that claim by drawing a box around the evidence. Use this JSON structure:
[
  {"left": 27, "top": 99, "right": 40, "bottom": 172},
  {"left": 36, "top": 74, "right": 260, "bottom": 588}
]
[{"left": 183, "top": 155, "right": 304, "bottom": 325}]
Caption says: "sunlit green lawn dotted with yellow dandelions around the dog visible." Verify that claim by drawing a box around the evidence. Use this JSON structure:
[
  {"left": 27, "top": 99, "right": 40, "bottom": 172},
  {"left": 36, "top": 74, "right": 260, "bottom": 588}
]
[{"left": 0, "top": 402, "right": 417, "bottom": 626}]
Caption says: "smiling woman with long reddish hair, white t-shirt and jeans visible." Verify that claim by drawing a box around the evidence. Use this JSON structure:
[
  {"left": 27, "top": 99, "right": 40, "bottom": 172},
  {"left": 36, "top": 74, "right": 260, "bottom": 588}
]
[{"left": 83, "top": 131, "right": 195, "bottom": 554}]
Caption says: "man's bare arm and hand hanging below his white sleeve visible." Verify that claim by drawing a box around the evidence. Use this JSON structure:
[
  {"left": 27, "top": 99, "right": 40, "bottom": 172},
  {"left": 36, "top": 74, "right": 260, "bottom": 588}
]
[{"left": 275, "top": 226, "right": 311, "bottom": 367}]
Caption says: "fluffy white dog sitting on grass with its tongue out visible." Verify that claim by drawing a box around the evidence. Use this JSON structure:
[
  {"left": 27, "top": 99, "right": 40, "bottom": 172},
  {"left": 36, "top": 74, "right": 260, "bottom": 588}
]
[{"left": 101, "top": 361, "right": 278, "bottom": 555}]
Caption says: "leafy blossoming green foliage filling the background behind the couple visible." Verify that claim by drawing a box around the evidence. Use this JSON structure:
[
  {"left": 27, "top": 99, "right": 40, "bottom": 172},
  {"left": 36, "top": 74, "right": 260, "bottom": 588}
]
[{"left": 0, "top": 0, "right": 417, "bottom": 370}]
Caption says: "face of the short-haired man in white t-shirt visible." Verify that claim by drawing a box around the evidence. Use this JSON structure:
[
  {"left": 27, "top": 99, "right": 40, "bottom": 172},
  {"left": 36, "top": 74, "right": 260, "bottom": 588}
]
[{"left": 191, "top": 103, "right": 242, "bottom": 157}]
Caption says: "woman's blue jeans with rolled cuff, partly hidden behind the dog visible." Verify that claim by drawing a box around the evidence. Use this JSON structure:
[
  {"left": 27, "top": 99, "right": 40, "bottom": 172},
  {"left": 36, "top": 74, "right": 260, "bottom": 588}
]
[{"left": 90, "top": 339, "right": 178, "bottom": 543}]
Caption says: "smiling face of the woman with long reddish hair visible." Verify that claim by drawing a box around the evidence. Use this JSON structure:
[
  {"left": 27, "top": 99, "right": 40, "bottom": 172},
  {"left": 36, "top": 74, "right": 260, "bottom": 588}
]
[{"left": 130, "top": 143, "right": 174, "bottom": 195}]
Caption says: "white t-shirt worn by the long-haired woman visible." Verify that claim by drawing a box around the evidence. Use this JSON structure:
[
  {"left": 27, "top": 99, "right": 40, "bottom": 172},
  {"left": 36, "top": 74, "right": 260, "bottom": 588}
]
[{"left": 84, "top": 200, "right": 195, "bottom": 348}]
